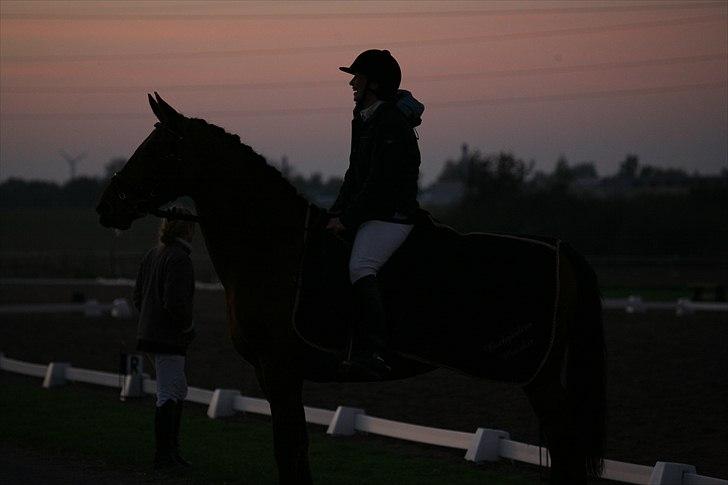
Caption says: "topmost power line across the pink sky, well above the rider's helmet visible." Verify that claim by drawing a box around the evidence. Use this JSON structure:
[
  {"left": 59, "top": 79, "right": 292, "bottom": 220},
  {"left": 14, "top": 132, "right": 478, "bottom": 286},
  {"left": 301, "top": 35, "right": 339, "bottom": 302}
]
[{"left": 0, "top": 2, "right": 725, "bottom": 21}]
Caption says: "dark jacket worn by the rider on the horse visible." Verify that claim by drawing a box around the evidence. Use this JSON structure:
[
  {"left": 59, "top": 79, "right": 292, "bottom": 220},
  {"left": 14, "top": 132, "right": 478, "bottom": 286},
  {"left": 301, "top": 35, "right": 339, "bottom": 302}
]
[{"left": 330, "top": 93, "right": 422, "bottom": 230}]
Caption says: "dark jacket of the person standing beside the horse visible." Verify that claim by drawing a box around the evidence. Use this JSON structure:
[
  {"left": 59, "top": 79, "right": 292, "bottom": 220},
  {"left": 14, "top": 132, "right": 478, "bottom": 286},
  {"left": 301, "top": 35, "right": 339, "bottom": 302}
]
[{"left": 134, "top": 242, "right": 195, "bottom": 355}]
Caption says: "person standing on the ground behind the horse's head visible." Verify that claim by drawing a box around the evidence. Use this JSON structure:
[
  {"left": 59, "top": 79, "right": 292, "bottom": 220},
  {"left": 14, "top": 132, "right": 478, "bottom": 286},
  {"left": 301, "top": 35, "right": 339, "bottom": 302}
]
[{"left": 133, "top": 207, "right": 195, "bottom": 470}]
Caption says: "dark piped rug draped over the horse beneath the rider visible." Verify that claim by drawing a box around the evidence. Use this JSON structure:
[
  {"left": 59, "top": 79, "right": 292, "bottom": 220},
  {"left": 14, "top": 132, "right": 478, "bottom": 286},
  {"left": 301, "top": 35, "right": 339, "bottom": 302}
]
[{"left": 294, "top": 210, "right": 558, "bottom": 384}]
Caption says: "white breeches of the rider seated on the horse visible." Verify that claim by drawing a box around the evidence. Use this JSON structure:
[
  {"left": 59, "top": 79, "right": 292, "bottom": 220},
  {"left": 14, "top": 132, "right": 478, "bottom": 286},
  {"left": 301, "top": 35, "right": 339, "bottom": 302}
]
[{"left": 349, "top": 221, "right": 414, "bottom": 283}]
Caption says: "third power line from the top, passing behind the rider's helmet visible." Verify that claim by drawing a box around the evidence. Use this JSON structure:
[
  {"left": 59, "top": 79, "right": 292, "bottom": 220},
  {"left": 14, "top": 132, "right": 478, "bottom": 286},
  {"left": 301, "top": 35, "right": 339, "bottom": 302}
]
[{"left": 0, "top": 52, "right": 728, "bottom": 94}]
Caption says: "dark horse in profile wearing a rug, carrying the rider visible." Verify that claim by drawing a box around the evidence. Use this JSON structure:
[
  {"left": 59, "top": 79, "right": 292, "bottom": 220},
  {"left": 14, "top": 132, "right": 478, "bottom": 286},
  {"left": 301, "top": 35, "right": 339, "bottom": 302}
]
[{"left": 97, "top": 93, "right": 605, "bottom": 484}]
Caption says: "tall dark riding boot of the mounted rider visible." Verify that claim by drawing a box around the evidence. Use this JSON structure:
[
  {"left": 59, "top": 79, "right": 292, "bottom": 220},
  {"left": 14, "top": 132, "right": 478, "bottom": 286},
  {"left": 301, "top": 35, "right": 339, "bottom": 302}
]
[{"left": 343, "top": 275, "right": 392, "bottom": 379}]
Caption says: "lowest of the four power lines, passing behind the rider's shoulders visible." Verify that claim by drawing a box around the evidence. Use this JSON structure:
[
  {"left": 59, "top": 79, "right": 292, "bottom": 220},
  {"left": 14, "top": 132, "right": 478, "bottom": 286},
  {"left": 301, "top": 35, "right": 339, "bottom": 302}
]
[{"left": 3, "top": 80, "right": 728, "bottom": 120}]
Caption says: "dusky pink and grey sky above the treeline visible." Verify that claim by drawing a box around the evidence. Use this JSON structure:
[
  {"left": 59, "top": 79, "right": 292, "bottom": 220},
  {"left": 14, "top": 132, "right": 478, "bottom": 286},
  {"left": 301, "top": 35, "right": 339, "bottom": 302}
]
[{"left": 0, "top": 0, "right": 728, "bottom": 184}]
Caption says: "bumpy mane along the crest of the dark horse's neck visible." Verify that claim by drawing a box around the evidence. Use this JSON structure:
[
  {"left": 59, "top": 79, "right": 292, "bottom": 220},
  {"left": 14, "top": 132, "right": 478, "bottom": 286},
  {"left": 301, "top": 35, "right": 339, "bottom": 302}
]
[{"left": 187, "top": 118, "right": 307, "bottom": 200}]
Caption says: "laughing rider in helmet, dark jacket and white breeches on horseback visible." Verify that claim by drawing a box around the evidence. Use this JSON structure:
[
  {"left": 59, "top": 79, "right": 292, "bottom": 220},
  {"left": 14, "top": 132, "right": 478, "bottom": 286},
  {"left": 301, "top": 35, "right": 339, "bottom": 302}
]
[{"left": 327, "top": 49, "right": 424, "bottom": 377}]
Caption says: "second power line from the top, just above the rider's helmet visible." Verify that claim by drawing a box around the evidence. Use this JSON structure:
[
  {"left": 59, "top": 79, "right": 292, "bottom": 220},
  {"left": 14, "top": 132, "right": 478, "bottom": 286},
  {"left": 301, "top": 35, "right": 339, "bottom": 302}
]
[{"left": 0, "top": 15, "right": 726, "bottom": 62}]
